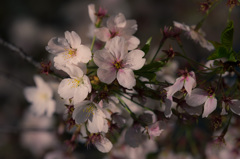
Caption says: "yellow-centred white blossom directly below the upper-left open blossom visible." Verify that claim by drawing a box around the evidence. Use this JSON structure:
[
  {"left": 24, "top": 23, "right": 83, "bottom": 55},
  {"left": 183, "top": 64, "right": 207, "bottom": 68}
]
[{"left": 58, "top": 65, "right": 92, "bottom": 105}]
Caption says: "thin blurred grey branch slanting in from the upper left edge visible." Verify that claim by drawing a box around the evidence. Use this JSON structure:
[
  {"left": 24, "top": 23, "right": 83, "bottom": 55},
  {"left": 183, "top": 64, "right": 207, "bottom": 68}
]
[{"left": 0, "top": 38, "right": 41, "bottom": 69}]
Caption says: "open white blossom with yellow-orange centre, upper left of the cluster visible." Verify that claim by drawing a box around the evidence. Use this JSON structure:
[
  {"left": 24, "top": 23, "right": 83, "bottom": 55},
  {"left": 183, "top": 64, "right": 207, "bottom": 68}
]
[{"left": 46, "top": 31, "right": 92, "bottom": 70}]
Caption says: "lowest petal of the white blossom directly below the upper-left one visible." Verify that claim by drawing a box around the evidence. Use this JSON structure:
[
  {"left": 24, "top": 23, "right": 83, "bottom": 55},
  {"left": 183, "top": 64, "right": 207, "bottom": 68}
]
[{"left": 73, "top": 84, "right": 88, "bottom": 105}]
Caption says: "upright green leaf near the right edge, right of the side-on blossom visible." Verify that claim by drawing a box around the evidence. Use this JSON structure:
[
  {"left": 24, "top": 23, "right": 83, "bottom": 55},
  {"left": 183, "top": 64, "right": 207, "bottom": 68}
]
[{"left": 221, "top": 21, "right": 234, "bottom": 49}]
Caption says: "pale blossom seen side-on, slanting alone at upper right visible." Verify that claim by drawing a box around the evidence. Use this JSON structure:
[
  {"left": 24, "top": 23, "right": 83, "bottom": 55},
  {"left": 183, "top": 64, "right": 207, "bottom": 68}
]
[{"left": 173, "top": 21, "right": 214, "bottom": 51}]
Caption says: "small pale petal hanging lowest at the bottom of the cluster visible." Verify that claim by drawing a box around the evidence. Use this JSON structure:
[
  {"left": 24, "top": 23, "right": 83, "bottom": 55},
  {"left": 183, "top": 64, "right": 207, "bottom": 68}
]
[{"left": 94, "top": 137, "right": 113, "bottom": 153}]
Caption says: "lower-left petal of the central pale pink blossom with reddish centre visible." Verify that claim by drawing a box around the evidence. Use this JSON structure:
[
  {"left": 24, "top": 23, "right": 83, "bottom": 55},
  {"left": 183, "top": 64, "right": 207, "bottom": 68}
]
[{"left": 97, "top": 68, "right": 116, "bottom": 84}]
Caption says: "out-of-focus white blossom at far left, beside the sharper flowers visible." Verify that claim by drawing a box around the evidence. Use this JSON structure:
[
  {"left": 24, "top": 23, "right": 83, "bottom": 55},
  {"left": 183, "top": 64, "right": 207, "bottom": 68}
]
[{"left": 24, "top": 75, "right": 56, "bottom": 116}]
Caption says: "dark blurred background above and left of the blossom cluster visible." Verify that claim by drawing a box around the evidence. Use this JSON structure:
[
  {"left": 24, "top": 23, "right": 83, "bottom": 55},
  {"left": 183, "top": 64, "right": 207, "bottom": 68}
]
[{"left": 0, "top": 0, "right": 240, "bottom": 159}]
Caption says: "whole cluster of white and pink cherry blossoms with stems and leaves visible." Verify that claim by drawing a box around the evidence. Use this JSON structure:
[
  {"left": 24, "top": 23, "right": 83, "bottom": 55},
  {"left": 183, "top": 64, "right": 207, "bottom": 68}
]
[{"left": 21, "top": 1, "right": 240, "bottom": 158}]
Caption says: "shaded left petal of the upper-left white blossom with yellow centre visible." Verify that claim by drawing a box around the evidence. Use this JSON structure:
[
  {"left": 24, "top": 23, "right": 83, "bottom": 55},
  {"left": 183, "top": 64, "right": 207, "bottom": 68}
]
[{"left": 46, "top": 37, "right": 70, "bottom": 54}]
